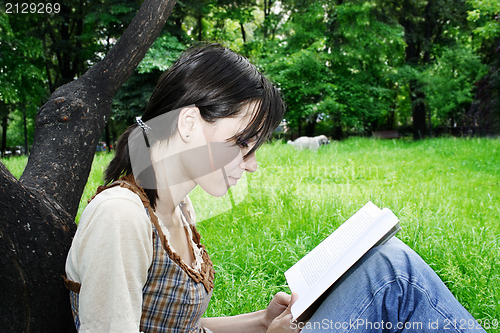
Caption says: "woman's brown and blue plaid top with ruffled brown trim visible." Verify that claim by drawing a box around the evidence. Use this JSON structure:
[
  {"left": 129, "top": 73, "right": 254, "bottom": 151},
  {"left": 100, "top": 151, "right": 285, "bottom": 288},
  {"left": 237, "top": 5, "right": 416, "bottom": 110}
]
[{"left": 65, "top": 176, "right": 214, "bottom": 333}]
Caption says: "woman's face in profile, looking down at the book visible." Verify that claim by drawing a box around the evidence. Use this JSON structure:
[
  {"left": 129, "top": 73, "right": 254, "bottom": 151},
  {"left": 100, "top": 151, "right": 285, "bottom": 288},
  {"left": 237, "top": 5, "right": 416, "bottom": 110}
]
[{"left": 194, "top": 103, "right": 257, "bottom": 197}]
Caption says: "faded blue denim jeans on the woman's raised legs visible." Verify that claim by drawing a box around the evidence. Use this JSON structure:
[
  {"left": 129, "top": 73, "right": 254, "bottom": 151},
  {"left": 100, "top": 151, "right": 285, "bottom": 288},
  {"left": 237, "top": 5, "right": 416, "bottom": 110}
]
[{"left": 299, "top": 237, "right": 485, "bottom": 333}]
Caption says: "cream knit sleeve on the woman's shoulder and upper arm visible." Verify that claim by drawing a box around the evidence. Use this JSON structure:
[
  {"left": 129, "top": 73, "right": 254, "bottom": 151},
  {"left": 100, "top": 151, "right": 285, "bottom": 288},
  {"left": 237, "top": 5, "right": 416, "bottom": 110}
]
[{"left": 66, "top": 188, "right": 152, "bottom": 332}]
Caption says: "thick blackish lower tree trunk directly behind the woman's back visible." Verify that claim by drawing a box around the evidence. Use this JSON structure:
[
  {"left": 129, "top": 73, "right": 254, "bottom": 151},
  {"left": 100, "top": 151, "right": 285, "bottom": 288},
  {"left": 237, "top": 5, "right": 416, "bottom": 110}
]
[{"left": 0, "top": 163, "right": 76, "bottom": 332}]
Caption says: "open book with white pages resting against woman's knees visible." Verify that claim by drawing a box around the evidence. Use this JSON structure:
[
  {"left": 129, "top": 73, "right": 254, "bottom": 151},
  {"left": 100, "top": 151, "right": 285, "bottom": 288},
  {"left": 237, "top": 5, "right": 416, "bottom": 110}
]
[{"left": 285, "top": 201, "right": 400, "bottom": 322}]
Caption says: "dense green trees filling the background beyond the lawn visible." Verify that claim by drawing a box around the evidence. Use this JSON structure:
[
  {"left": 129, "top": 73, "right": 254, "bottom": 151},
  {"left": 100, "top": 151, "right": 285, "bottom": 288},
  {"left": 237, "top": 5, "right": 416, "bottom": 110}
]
[{"left": 0, "top": 0, "right": 500, "bottom": 148}]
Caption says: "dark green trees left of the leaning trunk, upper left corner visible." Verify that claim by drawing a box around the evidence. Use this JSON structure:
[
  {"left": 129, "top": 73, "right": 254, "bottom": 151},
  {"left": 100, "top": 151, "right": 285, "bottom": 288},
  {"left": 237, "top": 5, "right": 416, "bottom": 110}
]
[{"left": 0, "top": 0, "right": 145, "bottom": 151}]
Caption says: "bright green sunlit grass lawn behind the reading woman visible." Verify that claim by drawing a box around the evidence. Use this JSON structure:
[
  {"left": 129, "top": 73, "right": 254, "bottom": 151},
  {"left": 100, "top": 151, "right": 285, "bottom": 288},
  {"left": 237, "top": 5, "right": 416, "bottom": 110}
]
[{"left": 4, "top": 138, "right": 500, "bottom": 332}]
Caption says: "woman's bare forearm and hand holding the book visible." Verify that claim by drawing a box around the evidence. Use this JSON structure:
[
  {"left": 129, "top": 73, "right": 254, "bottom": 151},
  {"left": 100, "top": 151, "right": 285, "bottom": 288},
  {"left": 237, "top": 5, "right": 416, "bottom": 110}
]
[{"left": 201, "top": 292, "right": 296, "bottom": 333}]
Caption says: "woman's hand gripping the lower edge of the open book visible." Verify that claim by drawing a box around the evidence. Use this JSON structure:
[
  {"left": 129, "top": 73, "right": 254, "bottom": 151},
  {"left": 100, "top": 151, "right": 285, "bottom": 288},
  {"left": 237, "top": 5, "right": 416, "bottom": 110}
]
[{"left": 266, "top": 292, "right": 300, "bottom": 333}]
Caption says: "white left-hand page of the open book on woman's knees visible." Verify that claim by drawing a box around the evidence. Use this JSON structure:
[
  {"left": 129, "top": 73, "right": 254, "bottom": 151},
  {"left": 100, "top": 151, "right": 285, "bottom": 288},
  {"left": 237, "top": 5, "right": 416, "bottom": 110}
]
[{"left": 285, "top": 202, "right": 381, "bottom": 297}]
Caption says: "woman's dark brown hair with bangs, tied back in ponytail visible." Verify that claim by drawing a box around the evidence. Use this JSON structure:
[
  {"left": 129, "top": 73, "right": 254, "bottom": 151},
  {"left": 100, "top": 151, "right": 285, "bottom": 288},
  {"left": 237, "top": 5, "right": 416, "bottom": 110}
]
[{"left": 105, "top": 45, "right": 285, "bottom": 208}]
